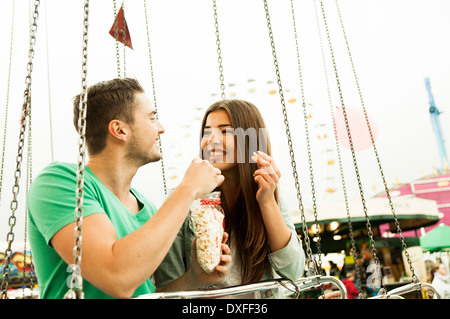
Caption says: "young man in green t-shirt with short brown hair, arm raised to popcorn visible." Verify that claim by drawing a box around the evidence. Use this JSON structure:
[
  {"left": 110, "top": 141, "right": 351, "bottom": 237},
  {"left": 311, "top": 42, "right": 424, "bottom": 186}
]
[{"left": 27, "top": 78, "right": 231, "bottom": 298}]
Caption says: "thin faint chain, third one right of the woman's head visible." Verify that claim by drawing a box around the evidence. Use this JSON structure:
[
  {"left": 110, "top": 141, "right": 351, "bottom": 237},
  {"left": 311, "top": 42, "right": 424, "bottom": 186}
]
[{"left": 314, "top": 0, "right": 364, "bottom": 299}]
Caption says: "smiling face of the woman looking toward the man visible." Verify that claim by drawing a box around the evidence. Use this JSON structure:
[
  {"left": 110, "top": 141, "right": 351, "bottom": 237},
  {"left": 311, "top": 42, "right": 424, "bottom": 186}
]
[{"left": 201, "top": 110, "right": 237, "bottom": 171}]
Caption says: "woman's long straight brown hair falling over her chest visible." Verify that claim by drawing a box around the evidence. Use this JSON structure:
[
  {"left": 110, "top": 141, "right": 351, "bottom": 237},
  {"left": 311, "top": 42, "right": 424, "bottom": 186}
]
[{"left": 200, "top": 100, "right": 278, "bottom": 284}]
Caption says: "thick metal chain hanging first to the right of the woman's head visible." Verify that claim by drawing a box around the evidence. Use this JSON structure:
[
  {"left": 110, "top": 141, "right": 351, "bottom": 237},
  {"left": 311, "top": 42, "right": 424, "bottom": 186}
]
[{"left": 264, "top": 0, "right": 318, "bottom": 274}]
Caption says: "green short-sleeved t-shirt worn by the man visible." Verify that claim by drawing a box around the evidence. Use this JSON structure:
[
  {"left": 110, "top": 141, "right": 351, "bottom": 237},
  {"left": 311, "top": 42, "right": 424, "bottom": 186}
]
[{"left": 27, "top": 162, "right": 156, "bottom": 299}]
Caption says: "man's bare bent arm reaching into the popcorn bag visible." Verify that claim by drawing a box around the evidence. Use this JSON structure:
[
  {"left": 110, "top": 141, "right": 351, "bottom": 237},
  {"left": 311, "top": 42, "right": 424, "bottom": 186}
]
[{"left": 51, "top": 161, "right": 223, "bottom": 298}]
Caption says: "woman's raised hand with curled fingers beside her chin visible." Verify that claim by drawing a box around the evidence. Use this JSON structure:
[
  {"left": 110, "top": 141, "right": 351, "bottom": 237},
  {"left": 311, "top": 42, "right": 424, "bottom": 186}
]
[{"left": 252, "top": 151, "right": 281, "bottom": 205}]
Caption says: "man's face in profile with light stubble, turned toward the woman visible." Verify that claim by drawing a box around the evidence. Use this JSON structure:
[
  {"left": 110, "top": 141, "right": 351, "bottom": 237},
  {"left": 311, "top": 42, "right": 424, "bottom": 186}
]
[{"left": 128, "top": 93, "right": 164, "bottom": 166}]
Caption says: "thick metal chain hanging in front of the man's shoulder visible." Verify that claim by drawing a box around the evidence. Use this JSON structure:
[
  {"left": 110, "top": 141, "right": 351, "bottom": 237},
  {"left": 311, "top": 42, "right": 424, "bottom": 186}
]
[{"left": 64, "top": 0, "right": 89, "bottom": 299}]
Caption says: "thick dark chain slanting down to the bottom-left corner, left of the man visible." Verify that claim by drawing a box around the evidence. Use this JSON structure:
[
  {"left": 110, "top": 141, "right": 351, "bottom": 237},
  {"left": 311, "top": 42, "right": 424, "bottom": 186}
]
[{"left": 1, "top": 0, "right": 40, "bottom": 299}]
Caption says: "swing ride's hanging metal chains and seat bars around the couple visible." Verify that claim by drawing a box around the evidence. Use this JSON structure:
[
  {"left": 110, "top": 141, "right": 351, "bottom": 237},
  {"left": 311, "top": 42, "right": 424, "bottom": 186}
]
[{"left": 0, "top": 0, "right": 446, "bottom": 299}]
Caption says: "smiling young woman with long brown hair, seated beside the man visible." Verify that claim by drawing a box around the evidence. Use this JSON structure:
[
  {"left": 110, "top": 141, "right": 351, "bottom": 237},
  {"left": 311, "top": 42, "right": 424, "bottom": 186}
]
[{"left": 155, "top": 100, "right": 305, "bottom": 298}]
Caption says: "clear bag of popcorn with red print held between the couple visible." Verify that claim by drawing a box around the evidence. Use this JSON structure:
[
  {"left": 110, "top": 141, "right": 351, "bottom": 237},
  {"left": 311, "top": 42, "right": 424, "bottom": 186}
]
[{"left": 191, "top": 192, "right": 224, "bottom": 274}]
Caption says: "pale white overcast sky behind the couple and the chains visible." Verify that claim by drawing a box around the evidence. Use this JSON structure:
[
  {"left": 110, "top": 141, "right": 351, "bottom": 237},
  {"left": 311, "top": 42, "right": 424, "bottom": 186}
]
[{"left": 0, "top": 0, "right": 450, "bottom": 248}]
